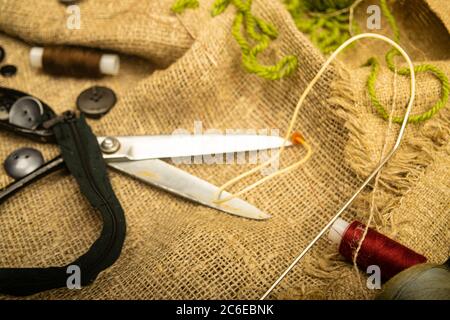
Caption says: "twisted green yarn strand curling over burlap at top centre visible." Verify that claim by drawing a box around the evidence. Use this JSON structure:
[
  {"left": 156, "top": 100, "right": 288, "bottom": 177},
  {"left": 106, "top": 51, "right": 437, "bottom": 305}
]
[{"left": 172, "top": 0, "right": 298, "bottom": 80}]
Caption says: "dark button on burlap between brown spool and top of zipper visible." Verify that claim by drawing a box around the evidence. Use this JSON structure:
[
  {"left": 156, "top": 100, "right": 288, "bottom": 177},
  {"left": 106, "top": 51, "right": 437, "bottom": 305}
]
[{"left": 77, "top": 86, "right": 117, "bottom": 118}]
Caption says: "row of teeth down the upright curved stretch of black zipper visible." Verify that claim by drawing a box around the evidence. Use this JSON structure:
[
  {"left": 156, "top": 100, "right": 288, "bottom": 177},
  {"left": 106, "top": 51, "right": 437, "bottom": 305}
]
[{"left": 69, "top": 120, "right": 117, "bottom": 268}]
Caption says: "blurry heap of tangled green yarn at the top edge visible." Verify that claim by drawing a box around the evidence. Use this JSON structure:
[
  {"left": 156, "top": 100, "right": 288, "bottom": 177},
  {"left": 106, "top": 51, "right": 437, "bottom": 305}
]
[{"left": 284, "top": 0, "right": 358, "bottom": 54}]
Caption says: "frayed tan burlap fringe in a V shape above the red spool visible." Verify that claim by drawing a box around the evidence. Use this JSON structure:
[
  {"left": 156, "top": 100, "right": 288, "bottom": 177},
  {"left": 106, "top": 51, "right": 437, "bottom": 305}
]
[{"left": 330, "top": 68, "right": 450, "bottom": 235}]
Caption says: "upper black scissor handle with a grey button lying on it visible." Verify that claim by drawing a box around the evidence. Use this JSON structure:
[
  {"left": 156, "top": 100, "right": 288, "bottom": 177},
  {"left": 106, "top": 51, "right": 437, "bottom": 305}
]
[{"left": 0, "top": 87, "right": 56, "bottom": 143}]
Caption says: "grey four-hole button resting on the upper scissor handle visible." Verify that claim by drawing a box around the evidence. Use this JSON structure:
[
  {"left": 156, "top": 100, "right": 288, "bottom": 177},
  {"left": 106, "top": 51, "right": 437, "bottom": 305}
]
[{"left": 9, "top": 96, "right": 44, "bottom": 129}]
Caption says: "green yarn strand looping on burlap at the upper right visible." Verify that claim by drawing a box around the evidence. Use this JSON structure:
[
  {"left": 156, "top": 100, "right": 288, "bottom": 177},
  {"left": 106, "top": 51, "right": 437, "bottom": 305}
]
[{"left": 366, "top": 0, "right": 450, "bottom": 123}]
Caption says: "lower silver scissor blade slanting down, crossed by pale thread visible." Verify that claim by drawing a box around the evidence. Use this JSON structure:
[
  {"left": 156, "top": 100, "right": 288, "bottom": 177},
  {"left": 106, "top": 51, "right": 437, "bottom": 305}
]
[{"left": 108, "top": 159, "right": 270, "bottom": 220}]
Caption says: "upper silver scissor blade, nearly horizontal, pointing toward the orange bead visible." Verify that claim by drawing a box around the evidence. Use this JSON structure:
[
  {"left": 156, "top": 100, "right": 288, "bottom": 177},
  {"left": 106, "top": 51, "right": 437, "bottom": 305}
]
[{"left": 97, "top": 134, "right": 291, "bottom": 160}]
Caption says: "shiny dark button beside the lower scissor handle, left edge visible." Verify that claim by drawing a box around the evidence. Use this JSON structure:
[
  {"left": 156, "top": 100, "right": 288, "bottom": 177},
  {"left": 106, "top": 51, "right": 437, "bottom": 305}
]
[{"left": 3, "top": 148, "right": 44, "bottom": 179}]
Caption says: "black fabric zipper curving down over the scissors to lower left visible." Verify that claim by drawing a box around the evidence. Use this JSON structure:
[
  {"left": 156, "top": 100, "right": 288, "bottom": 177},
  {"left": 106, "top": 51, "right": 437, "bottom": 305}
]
[{"left": 0, "top": 113, "right": 126, "bottom": 296}]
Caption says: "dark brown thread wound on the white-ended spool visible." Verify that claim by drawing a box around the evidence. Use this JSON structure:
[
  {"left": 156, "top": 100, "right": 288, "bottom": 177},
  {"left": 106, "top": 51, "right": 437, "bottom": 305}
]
[{"left": 42, "top": 47, "right": 102, "bottom": 78}]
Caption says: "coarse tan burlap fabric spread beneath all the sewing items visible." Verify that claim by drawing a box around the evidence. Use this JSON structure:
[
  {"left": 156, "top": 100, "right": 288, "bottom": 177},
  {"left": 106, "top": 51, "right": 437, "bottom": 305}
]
[{"left": 0, "top": 0, "right": 450, "bottom": 299}]
